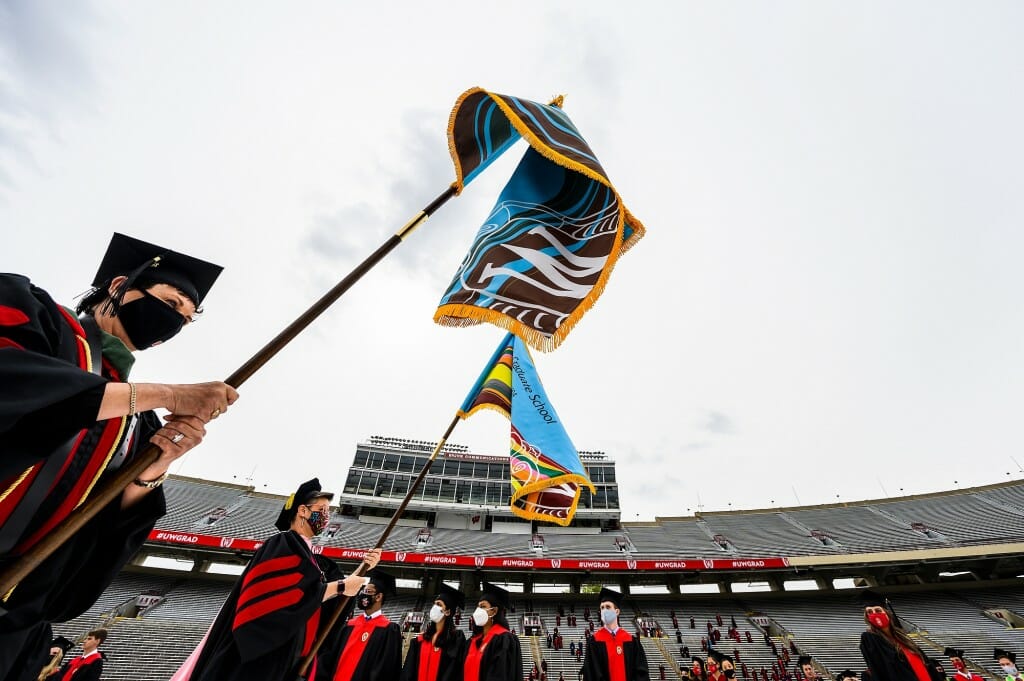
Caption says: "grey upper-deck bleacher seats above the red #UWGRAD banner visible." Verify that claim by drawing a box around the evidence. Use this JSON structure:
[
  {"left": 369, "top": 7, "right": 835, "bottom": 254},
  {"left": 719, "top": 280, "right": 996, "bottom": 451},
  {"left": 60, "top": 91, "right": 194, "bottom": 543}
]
[{"left": 158, "top": 478, "right": 1024, "bottom": 559}]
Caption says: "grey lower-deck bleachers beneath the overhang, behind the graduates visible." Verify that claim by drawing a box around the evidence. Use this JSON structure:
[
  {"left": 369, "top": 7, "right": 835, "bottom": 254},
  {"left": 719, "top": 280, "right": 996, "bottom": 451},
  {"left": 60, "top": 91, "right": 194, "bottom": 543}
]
[{"left": 54, "top": 571, "right": 1024, "bottom": 681}]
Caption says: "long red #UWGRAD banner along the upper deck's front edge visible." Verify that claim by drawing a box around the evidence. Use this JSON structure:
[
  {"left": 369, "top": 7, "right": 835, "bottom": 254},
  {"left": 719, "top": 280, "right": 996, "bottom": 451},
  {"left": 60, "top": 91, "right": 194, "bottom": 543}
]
[{"left": 148, "top": 529, "right": 790, "bottom": 572}]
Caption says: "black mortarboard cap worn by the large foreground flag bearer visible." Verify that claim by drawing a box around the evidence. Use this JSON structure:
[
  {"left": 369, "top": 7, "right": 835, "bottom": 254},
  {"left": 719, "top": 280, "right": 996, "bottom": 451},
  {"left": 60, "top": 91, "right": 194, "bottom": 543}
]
[{"left": 92, "top": 232, "right": 223, "bottom": 312}]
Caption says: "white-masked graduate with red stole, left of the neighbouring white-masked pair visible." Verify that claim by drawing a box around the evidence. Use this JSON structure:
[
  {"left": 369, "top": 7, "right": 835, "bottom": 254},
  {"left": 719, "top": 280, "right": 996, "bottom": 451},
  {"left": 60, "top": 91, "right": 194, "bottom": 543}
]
[{"left": 400, "top": 583, "right": 466, "bottom": 681}]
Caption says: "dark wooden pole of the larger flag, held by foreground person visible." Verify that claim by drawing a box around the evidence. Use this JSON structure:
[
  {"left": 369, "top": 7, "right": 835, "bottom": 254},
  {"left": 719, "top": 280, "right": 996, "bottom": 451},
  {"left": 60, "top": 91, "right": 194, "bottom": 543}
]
[{"left": 0, "top": 184, "right": 458, "bottom": 598}]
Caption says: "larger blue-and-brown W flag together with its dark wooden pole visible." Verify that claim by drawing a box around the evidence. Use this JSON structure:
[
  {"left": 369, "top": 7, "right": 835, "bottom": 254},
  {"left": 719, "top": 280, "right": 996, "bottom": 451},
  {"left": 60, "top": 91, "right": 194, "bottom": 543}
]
[{"left": 0, "top": 82, "right": 644, "bottom": 614}]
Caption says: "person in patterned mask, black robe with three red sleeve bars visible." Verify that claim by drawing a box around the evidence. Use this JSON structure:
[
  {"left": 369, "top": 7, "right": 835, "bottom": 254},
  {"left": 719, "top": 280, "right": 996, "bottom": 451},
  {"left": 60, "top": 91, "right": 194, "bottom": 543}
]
[{"left": 182, "top": 478, "right": 379, "bottom": 681}]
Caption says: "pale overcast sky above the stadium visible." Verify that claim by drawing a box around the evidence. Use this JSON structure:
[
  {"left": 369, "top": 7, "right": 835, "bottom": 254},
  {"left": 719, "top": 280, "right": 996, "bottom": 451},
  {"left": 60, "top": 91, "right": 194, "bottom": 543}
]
[{"left": 0, "top": 0, "right": 1024, "bottom": 520}]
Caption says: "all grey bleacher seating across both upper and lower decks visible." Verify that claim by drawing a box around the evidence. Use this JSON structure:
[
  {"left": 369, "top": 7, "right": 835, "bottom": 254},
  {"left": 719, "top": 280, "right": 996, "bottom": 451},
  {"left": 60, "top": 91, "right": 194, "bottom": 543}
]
[{"left": 46, "top": 478, "right": 1024, "bottom": 681}]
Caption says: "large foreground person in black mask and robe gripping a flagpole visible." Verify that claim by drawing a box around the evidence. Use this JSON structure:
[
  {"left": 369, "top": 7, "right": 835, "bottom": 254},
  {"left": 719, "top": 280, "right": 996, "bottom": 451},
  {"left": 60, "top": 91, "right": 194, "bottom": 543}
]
[{"left": 0, "top": 235, "right": 238, "bottom": 681}]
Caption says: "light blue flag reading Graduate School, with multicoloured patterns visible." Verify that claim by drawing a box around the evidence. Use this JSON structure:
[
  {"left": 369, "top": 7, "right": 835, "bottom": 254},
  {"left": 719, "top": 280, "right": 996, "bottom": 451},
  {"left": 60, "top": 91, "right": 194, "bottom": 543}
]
[{"left": 459, "top": 334, "right": 595, "bottom": 525}]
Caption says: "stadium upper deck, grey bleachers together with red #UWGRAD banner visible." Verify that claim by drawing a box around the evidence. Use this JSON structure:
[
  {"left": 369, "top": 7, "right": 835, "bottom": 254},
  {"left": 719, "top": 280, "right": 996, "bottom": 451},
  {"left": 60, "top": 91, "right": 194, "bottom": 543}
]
[{"left": 151, "top": 477, "right": 1024, "bottom": 577}]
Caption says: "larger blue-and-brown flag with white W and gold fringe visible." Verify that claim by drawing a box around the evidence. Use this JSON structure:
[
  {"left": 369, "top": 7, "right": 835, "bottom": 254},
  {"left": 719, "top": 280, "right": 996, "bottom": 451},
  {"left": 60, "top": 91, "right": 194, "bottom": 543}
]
[{"left": 434, "top": 88, "right": 644, "bottom": 351}]
